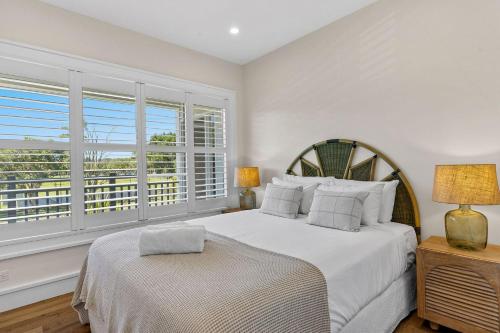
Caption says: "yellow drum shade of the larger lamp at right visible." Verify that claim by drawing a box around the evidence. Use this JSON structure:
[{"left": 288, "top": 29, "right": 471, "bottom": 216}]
[{"left": 432, "top": 164, "right": 500, "bottom": 205}]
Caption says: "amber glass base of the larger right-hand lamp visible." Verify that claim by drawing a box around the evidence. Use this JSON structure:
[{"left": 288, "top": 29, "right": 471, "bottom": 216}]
[{"left": 445, "top": 205, "right": 488, "bottom": 250}]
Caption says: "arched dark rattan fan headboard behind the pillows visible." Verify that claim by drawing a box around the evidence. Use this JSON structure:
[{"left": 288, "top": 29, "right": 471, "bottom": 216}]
[{"left": 287, "top": 139, "right": 420, "bottom": 236}]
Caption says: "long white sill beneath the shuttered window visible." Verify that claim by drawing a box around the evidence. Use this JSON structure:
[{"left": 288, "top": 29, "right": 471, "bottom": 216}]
[{"left": 0, "top": 207, "right": 225, "bottom": 261}]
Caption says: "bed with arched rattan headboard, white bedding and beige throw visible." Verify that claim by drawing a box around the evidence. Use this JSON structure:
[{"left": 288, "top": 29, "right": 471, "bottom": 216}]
[{"left": 73, "top": 140, "right": 419, "bottom": 332}]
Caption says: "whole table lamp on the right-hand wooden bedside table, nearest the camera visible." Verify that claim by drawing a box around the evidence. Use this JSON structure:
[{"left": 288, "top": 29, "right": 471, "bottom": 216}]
[{"left": 432, "top": 164, "right": 500, "bottom": 250}]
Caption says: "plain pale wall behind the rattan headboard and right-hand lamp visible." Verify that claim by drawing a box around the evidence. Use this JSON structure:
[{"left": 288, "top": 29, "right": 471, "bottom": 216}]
[{"left": 241, "top": 0, "right": 500, "bottom": 243}]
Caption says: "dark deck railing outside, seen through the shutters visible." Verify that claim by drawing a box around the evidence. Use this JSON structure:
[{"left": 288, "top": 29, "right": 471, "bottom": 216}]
[{"left": 0, "top": 175, "right": 184, "bottom": 224}]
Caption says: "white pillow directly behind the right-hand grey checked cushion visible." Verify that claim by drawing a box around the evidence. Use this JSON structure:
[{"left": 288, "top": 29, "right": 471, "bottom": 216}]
[{"left": 318, "top": 182, "right": 384, "bottom": 225}]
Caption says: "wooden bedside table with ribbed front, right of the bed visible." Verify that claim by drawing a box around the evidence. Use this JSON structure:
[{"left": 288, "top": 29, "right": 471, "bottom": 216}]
[{"left": 417, "top": 237, "right": 500, "bottom": 333}]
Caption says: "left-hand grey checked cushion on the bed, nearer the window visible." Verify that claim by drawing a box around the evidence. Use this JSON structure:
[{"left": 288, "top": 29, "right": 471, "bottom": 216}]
[{"left": 260, "top": 184, "right": 302, "bottom": 219}]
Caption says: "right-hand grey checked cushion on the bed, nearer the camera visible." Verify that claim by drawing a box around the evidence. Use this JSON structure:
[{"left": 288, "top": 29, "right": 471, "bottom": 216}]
[{"left": 309, "top": 190, "right": 369, "bottom": 231}]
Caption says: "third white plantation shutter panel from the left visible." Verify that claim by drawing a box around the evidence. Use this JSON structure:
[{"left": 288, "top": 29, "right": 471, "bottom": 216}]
[{"left": 144, "top": 84, "right": 188, "bottom": 217}]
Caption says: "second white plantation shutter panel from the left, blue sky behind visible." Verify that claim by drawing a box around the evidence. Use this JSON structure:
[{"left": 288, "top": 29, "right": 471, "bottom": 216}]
[{"left": 82, "top": 74, "right": 139, "bottom": 226}]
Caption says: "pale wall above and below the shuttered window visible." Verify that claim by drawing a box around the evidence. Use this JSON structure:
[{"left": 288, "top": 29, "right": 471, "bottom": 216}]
[{"left": 0, "top": 0, "right": 242, "bottom": 312}]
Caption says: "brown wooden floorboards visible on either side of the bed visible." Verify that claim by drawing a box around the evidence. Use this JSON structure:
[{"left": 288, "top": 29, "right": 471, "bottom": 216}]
[{"left": 0, "top": 294, "right": 458, "bottom": 333}]
